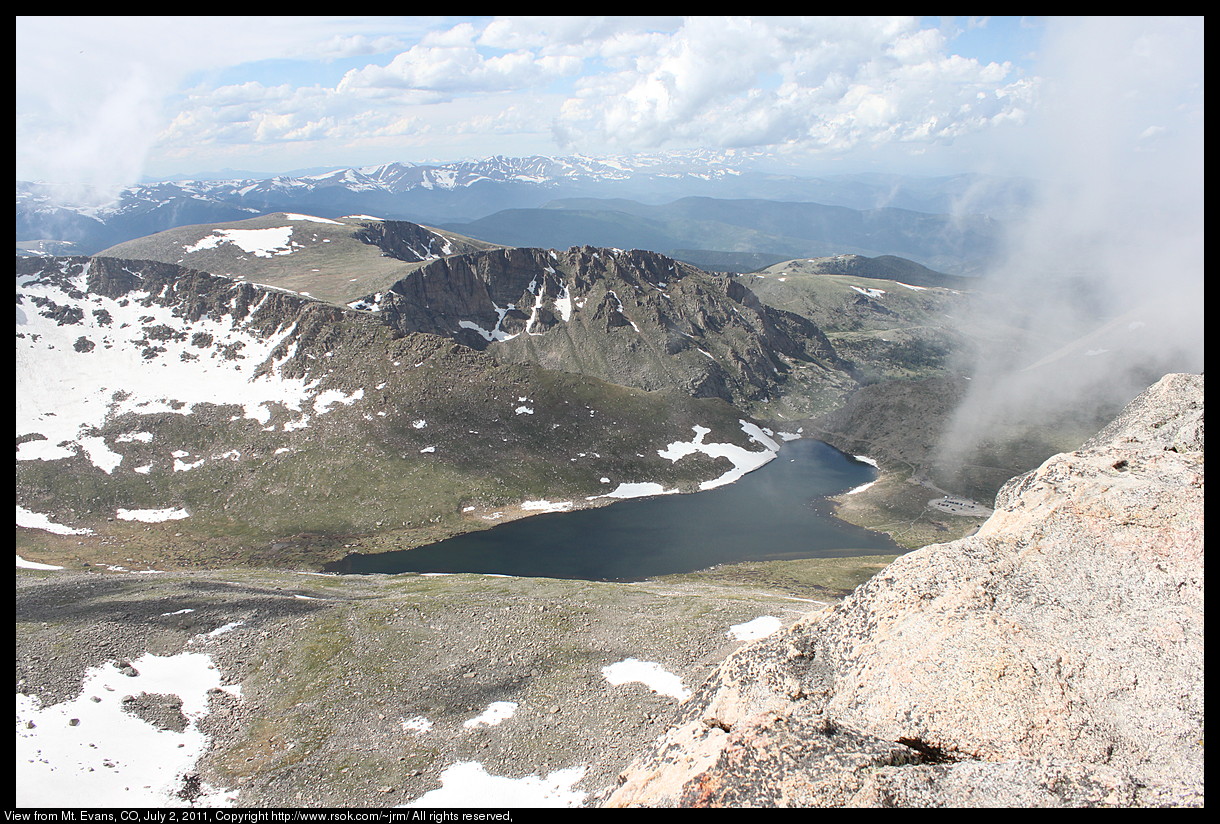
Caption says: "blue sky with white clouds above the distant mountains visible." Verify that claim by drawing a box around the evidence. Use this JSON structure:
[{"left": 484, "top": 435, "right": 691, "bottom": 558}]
[{"left": 9, "top": 17, "right": 1098, "bottom": 184}]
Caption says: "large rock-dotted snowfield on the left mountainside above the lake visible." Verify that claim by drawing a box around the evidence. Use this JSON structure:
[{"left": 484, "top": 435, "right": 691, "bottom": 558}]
[{"left": 16, "top": 264, "right": 364, "bottom": 474}]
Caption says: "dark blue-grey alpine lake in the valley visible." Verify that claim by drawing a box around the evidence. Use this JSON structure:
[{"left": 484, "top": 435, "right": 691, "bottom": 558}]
[{"left": 329, "top": 439, "right": 904, "bottom": 581}]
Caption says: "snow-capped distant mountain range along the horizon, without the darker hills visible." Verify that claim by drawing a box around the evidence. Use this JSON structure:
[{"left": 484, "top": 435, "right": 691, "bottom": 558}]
[{"left": 16, "top": 155, "right": 1028, "bottom": 264}]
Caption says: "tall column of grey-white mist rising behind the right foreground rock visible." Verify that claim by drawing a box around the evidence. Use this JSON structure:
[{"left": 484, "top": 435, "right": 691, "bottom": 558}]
[{"left": 939, "top": 18, "right": 1203, "bottom": 476}]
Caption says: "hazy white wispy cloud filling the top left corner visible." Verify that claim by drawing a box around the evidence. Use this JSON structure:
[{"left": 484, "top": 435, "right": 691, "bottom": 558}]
[{"left": 15, "top": 16, "right": 439, "bottom": 188}]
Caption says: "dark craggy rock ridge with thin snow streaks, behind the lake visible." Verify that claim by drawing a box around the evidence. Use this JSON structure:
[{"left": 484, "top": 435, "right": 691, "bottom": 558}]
[{"left": 366, "top": 247, "right": 854, "bottom": 403}]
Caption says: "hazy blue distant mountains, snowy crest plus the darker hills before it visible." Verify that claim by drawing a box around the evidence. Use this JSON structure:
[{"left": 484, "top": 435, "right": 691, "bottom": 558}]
[{"left": 16, "top": 153, "right": 1031, "bottom": 272}]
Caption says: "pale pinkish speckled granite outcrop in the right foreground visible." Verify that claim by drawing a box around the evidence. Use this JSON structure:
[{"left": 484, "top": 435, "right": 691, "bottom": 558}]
[{"left": 606, "top": 375, "right": 1203, "bottom": 806}]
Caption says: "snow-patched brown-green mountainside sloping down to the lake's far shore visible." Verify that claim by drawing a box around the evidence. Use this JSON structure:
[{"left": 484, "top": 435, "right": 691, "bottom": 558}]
[{"left": 17, "top": 247, "right": 819, "bottom": 565}]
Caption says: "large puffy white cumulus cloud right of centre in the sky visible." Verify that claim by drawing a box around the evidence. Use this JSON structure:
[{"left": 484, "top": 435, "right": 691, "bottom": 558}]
[{"left": 555, "top": 17, "right": 1036, "bottom": 151}]
